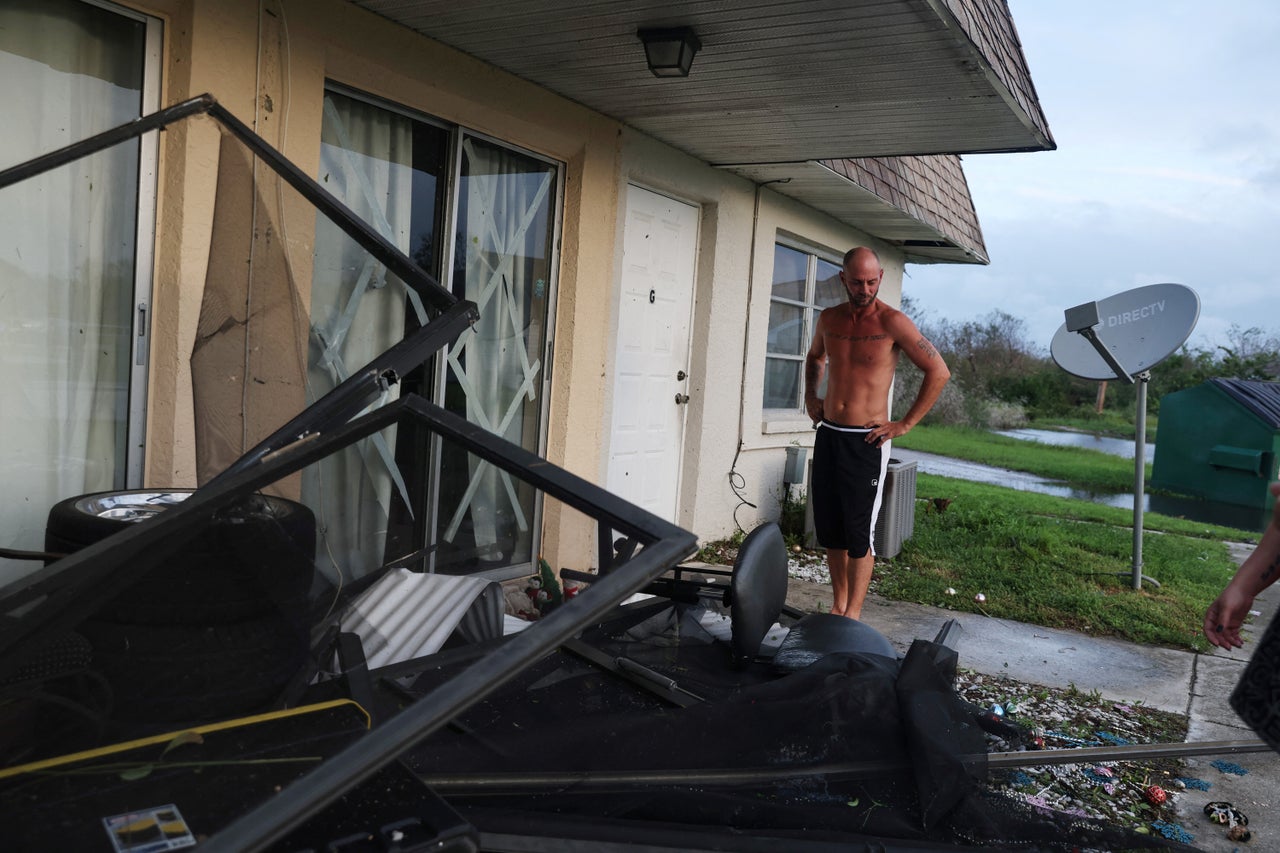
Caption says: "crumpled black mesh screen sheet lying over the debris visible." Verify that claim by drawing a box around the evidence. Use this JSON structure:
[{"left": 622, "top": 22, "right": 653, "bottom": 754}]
[{"left": 404, "top": 596, "right": 1179, "bottom": 850}]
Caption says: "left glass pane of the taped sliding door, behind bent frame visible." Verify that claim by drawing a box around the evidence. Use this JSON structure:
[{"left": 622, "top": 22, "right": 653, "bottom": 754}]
[{"left": 302, "top": 90, "right": 451, "bottom": 579}]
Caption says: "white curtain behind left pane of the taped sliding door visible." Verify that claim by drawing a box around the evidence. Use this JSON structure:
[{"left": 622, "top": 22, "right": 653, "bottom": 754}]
[{"left": 302, "top": 92, "right": 412, "bottom": 583}]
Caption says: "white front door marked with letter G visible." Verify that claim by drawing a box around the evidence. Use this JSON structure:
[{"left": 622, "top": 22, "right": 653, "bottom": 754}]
[{"left": 608, "top": 186, "right": 699, "bottom": 521}]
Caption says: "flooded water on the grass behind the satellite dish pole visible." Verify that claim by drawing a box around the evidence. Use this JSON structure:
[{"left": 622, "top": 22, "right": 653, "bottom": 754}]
[{"left": 893, "top": 430, "right": 1267, "bottom": 530}]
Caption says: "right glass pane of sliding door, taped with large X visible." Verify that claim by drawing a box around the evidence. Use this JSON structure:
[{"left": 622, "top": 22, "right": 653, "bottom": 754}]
[{"left": 438, "top": 133, "right": 559, "bottom": 576}]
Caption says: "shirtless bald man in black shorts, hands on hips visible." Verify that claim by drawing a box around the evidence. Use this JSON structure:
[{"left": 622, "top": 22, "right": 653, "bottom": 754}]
[{"left": 804, "top": 247, "right": 951, "bottom": 619}]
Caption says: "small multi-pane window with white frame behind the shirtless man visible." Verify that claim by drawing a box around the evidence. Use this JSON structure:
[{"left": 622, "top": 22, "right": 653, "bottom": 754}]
[{"left": 764, "top": 243, "right": 846, "bottom": 410}]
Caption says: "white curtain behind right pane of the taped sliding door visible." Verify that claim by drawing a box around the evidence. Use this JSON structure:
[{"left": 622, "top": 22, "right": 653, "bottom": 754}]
[{"left": 444, "top": 138, "right": 556, "bottom": 565}]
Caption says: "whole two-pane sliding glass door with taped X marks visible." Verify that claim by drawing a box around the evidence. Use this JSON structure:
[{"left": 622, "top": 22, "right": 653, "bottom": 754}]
[{"left": 302, "top": 87, "right": 559, "bottom": 578}]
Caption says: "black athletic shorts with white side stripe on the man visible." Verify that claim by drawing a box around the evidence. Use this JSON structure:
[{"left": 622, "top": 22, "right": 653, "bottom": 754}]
[{"left": 809, "top": 420, "right": 892, "bottom": 557}]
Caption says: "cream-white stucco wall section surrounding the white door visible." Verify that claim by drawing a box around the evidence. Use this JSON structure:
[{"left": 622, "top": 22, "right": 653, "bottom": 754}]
[{"left": 611, "top": 131, "right": 904, "bottom": 540}]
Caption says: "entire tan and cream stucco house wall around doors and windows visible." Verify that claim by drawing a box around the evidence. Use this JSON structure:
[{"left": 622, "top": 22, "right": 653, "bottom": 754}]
[{"left": 122, "top": 0, "right": 902, "bottom": 565}]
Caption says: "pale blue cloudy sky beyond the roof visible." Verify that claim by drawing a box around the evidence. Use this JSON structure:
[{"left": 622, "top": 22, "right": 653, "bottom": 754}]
[{"left": 904, "top": 0, "right": 1280, "bottom": 352}]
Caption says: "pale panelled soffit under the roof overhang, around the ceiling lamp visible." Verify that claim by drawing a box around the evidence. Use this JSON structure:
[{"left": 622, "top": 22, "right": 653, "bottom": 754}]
[{"left": 351, "top": 0, "right": 1056, "bottom": 264}]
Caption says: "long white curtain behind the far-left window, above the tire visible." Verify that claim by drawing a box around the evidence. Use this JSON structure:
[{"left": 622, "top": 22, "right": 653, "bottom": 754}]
[{"left": 0, "top": 0, "right": 143, "bottom": 583}]
